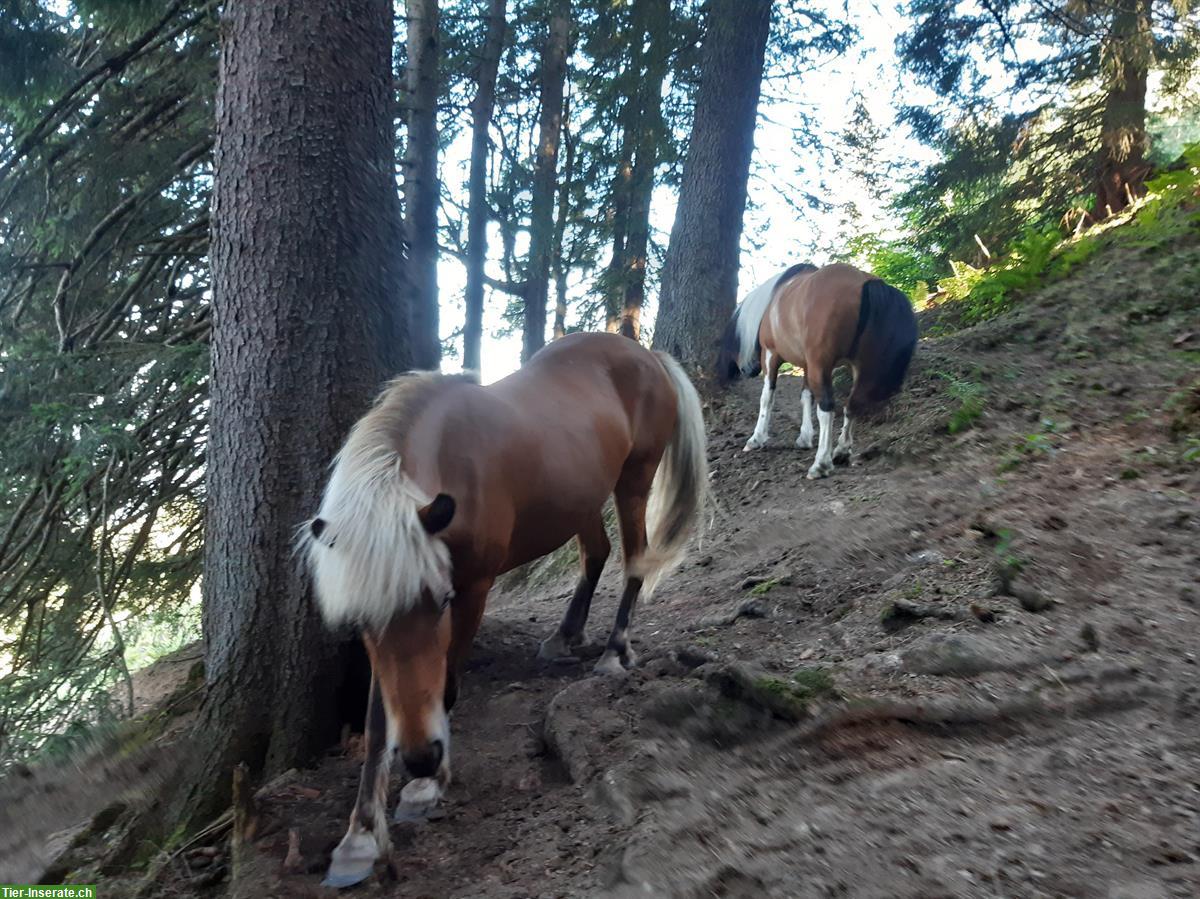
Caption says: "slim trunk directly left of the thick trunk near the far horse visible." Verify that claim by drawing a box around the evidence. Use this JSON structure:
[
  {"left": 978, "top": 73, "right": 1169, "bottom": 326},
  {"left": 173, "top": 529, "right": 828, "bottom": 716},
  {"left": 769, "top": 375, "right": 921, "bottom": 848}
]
[{"left": 619, "top": 0, "right": 671, "bottom": 340}]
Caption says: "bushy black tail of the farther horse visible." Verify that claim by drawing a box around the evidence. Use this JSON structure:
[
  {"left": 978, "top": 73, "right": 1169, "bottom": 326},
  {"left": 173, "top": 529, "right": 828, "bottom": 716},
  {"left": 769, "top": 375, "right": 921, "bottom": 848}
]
[{"left": 854, "top": 278, "right": 917, "bottom": 403}]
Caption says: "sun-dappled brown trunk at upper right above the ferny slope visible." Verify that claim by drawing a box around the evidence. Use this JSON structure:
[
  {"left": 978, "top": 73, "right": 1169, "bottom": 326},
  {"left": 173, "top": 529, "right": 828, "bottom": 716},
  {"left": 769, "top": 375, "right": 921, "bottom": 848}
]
[{"left": 1093, "top": 0, "right": 1153, "bottom": 218}]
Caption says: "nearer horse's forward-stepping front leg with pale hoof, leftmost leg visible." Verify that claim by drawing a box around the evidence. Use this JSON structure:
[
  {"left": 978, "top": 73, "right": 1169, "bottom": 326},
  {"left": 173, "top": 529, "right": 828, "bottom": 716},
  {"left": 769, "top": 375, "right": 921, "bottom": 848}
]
[{"left": 325, "top": 673, "right": 395, "bottom": 887}]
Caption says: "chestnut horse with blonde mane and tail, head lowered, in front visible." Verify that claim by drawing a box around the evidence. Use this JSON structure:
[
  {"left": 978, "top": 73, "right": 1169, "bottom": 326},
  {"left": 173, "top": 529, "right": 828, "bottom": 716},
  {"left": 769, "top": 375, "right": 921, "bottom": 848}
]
[{"left": 301, "top": 334, "right": 708, "bottom": 886}]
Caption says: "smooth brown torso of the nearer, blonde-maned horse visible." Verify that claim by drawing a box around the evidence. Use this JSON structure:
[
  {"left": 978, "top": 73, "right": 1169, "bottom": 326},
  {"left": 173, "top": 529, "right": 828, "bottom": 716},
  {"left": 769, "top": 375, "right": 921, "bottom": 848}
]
[{"left": 421, "top": 334, "right": 676, "bottom": 569}]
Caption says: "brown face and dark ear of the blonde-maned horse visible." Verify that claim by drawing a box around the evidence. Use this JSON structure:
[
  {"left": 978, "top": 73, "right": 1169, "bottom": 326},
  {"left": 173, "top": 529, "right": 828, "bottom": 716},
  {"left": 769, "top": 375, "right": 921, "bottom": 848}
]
[{"left": 364, "top": 493, "right": 455, "bottom": 781}]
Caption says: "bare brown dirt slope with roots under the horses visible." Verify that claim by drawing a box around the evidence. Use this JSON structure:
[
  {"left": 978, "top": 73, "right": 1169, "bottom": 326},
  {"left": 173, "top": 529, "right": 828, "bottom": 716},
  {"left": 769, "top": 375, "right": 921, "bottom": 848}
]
[{"left": 9, "top": 232, "right": 1200, "bottom": 899}]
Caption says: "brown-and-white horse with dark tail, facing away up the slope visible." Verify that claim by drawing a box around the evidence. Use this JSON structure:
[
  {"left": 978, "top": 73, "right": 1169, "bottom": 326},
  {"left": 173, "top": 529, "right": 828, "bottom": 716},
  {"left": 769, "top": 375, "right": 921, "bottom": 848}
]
[{"left": 716, "top": 264, "right": 917, "bottom": 478}]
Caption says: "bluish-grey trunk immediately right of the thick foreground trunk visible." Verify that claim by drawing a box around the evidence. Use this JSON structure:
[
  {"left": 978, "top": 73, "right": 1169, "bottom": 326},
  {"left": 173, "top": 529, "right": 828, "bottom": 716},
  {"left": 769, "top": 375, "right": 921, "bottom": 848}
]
[{"left": 404, "top": 0, "right": 442, "bottom": 368}]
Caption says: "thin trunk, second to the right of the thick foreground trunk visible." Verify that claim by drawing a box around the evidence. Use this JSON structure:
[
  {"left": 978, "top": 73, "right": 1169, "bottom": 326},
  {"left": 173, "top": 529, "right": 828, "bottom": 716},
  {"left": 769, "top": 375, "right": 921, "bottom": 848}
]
[{"left": 462, "top": 0, "right": 505, "bottom": 371}]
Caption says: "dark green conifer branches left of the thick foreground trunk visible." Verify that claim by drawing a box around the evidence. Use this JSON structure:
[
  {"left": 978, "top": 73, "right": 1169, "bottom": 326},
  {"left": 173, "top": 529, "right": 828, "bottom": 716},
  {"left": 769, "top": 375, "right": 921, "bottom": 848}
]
[{"left": 0, "top": 0, "right": 217, "bottom": 768}]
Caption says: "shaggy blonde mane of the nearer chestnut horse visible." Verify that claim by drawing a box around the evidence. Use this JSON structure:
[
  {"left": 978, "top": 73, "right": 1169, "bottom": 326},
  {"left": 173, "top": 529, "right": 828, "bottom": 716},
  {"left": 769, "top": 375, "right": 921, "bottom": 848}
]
[{"left": 300, "top": 372, "right": 464, "bottom": 629}]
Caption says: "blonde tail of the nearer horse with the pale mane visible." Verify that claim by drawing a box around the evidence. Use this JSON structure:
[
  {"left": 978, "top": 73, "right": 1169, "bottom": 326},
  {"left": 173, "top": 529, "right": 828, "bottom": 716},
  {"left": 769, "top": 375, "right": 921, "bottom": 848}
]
[{"left": 637, "top": 353, "right": 709, "bottom": 595}]
